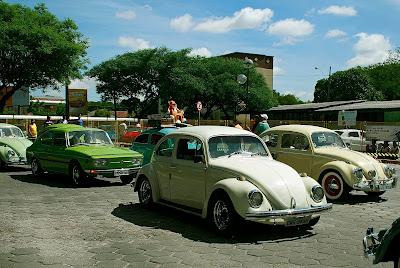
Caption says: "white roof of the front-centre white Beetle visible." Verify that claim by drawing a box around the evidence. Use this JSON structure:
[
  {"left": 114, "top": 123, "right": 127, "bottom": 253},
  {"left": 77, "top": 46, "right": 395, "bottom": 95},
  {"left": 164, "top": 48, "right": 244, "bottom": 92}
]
[{"left": 168, "top": 126, "right": 257, "bottom": 139}]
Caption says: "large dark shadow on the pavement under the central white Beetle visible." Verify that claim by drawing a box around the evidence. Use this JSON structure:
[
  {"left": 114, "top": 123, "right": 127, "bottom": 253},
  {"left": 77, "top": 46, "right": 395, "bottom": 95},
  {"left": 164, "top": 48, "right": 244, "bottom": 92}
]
[{"left": 111, "top": 203, "right": 315, "bottom": 244}]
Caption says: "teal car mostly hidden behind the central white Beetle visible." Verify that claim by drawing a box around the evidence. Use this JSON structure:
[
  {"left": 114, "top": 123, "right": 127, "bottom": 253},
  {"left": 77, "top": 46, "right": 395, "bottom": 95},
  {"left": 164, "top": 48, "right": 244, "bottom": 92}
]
[{"left": 131, "top": 127, "right": 178, "bottom": 165}]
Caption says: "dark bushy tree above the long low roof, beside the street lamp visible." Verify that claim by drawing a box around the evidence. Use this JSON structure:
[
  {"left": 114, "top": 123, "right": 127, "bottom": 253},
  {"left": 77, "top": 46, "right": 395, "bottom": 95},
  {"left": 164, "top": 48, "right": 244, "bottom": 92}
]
[{"left": 314, "top": 67, "right": 383, "bottom": 102}]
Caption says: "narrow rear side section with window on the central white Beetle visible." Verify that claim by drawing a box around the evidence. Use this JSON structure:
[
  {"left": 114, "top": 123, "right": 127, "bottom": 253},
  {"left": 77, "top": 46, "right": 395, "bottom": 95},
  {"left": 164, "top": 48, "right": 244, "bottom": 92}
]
[{"left": 152, "top": 137, "right": 176, "bottom": 201}]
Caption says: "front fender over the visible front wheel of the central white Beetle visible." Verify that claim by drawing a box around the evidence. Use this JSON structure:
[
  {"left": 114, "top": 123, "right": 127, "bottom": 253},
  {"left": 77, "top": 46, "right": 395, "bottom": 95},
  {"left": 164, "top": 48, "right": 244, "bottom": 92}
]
[{"left": 201, "top": 178, "right": 272, "bottom": 218}]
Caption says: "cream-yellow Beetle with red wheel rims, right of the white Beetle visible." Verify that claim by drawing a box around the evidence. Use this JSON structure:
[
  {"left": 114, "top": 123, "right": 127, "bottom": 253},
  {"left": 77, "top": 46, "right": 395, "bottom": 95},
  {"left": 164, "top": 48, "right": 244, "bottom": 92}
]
[{"left": 260, "top": 125, "right": 397, "bottom": 200}]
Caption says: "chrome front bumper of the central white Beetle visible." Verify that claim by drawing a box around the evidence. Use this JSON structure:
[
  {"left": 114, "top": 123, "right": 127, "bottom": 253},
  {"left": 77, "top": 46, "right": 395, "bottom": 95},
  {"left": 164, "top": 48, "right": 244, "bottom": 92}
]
[{"left": 245, "top": 204, "right": 332, "bottom": 221}]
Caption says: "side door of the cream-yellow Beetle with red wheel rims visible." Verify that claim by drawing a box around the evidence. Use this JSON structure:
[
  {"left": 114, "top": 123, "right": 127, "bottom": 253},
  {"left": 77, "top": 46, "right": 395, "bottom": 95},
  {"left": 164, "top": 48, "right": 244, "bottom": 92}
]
[{"left": 275, "top": 132, "right": 313, "bottom": 174}]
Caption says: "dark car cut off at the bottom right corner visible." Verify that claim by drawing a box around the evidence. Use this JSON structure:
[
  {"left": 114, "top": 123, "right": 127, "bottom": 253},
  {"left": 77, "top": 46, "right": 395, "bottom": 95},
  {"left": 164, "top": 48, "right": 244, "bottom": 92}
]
[{"left": 363, "top": 218, "right": 400, "bottom": 268}]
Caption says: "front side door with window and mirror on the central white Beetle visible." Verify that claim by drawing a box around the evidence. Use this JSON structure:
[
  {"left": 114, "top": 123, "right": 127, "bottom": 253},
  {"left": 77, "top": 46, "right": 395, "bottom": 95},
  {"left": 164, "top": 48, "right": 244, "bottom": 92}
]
[{"left": 170, "top": 137, "right": 207, "bottom": 209}]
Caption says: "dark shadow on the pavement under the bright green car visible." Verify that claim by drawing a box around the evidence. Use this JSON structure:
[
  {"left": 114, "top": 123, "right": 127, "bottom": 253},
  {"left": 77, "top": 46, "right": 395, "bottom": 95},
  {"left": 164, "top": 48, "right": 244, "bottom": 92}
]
[{"left": 10, "top": 174, "right": 123, "bottom": 188}]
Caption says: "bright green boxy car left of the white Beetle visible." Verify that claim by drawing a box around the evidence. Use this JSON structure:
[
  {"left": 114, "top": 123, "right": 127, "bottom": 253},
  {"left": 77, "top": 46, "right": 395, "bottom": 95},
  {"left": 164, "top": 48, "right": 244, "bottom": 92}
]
[{"left": 26, "top": 124, "right": 143, "bottom": 185}]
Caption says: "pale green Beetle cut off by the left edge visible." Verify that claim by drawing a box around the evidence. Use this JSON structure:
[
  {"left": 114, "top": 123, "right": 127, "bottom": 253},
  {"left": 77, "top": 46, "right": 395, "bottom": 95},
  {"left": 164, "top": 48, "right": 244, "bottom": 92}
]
[{"left": 0, "top": 123, "right": 32, "bottom": 169}]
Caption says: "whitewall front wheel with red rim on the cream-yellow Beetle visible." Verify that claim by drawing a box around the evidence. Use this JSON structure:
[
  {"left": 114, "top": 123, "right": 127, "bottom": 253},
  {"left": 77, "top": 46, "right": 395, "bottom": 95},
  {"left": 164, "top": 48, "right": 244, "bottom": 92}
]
[{"left": 321, "top": 171, "right": 350, "bottom": 200}]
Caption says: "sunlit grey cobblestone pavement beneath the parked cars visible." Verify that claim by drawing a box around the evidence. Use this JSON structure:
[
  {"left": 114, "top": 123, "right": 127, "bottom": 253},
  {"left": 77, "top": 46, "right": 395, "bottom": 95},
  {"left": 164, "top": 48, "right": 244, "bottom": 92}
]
[{"left": 0, "top": 168, "right": 400, "bottom": 268}]
